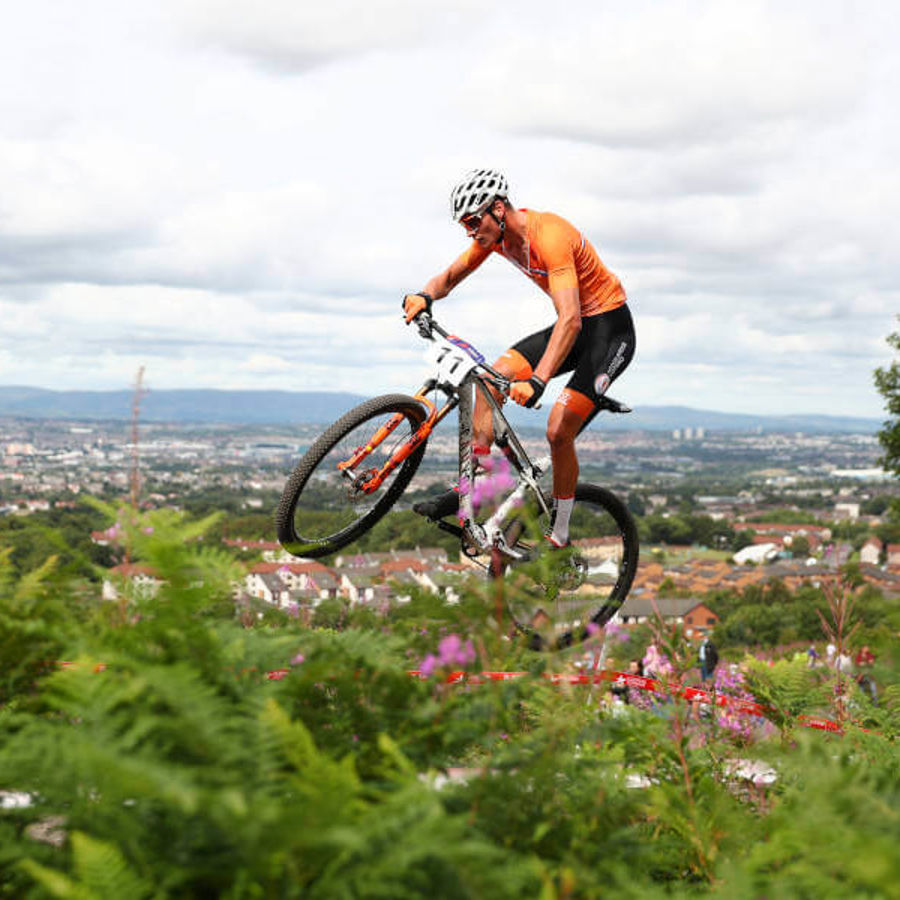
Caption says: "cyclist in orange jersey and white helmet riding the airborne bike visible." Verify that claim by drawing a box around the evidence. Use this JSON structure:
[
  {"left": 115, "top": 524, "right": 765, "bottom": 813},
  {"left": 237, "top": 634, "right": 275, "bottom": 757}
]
[{"left": 403, "top": 169, "right": 635, "bottom": 547}]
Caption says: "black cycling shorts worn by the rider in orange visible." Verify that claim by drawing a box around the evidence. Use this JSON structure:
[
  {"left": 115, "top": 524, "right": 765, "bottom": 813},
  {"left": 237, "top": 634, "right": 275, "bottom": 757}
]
[{"left": 512, "top": 304, "right": 635, "bottom": 418}]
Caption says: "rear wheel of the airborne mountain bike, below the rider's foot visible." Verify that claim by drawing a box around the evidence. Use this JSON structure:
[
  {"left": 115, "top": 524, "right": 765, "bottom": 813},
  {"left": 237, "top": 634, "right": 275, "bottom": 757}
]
[{"left": 504, "top": 484, "right": 639, "bottom": 649}]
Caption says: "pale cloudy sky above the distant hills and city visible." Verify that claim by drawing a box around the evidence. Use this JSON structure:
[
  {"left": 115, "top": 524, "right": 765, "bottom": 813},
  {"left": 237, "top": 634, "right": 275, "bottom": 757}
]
[{"left": 0, "top": 0, "right": 900, "bottom": 418}]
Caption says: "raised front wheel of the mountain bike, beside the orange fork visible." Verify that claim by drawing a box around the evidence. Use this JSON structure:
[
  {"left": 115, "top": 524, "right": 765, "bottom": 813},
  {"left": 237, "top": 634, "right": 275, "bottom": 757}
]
[{"left": 275, "top": 394, "right": 425, "bottom": 558}]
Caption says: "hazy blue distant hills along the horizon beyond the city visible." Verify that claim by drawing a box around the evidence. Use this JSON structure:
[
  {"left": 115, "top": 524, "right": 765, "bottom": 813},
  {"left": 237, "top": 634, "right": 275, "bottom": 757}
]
[{"left": 0, "top": 387, "right": 882, "bottom": 434}]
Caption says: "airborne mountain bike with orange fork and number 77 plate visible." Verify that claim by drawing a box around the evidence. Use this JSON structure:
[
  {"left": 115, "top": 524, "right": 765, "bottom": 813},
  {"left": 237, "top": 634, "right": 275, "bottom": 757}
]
[{"left": 275, "top": 312, "right": 638, "bottom": 649}]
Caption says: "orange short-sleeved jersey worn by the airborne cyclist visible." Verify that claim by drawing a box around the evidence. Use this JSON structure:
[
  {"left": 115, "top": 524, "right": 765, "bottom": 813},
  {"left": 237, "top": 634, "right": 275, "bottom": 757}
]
[{"left": 461, "top": 209, "right": 625, "bottom": 316}]
